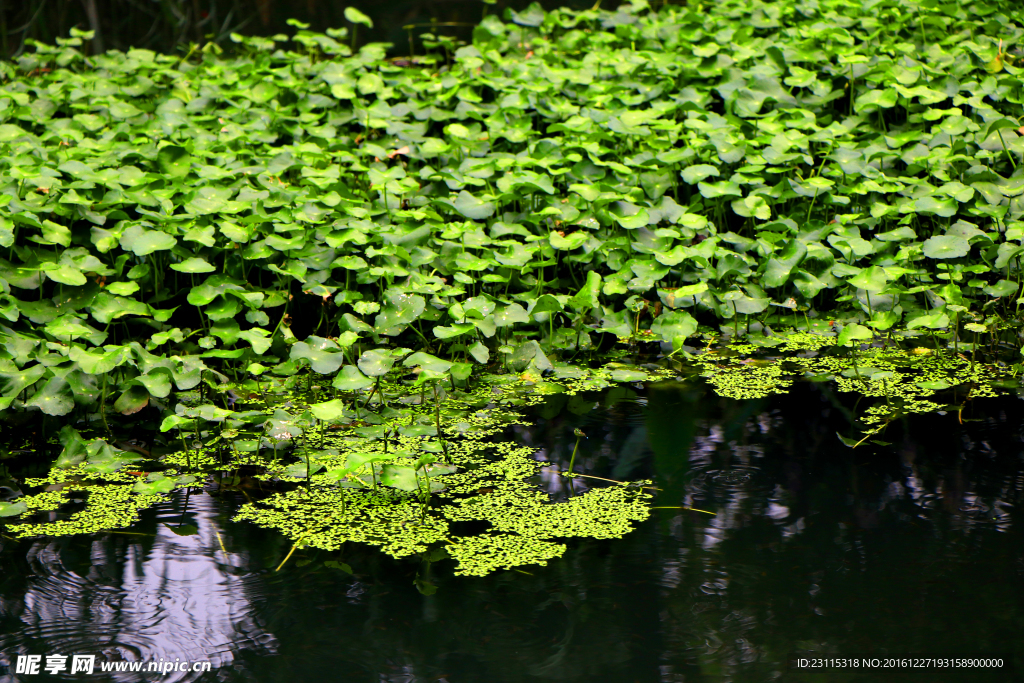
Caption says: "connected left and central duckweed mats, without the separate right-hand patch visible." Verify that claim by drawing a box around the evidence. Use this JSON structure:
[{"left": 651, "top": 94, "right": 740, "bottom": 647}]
[{"left": 5, "top": 360, "right": 672, "bottom": 575}]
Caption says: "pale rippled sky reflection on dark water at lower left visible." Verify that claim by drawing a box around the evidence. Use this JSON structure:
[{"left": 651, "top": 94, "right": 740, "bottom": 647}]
[{"left": 0, "top": 496, "right": 276, "bottom": 681}]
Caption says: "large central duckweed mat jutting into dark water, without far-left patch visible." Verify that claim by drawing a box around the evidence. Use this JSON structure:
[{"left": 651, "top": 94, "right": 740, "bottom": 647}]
[{"left": 234, "top": 369, "right": 655, "bottom": 575}]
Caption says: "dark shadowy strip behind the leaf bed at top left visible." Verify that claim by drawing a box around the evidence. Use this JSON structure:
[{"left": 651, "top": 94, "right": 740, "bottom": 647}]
[{"left": 0, "top": 0, "right": 606, "bottom": 58}]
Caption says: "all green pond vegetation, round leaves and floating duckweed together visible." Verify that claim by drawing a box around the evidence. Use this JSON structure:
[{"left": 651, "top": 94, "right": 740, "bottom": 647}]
[{"left": 0, "top": 0, "right": 1024, "bottom": 572}]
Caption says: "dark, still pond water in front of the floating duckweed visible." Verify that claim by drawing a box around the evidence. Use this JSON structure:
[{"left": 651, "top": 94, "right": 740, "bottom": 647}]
[{"left": 0, "top": 384, "right": 1024, "bottom": 683}]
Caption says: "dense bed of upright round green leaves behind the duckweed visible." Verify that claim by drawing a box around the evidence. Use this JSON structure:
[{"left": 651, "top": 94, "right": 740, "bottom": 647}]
[{"left": 0, "top": 0, "right": 1024, "bottom": 415}]
